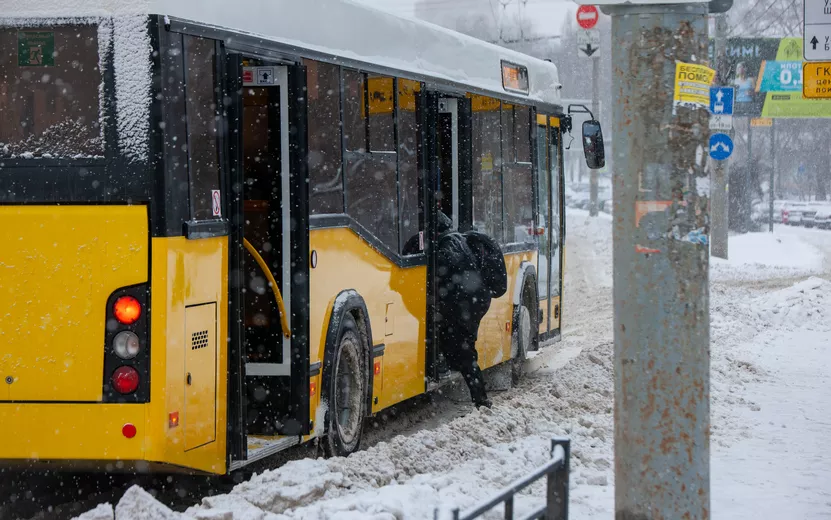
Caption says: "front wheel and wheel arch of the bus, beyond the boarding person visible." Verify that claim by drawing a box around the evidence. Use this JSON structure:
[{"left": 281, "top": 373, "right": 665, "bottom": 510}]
[{"left": 511, "top": 262, "right": 539, "bottom": 385}]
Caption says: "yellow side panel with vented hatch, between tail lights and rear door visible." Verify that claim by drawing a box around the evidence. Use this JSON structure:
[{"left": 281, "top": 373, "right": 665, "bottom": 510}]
[{"left": 145, "top": 237, "right": 228, "bottom": 473}]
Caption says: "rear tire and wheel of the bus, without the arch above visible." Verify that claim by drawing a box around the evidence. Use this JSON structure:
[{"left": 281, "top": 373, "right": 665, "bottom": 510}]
[{"left": 322, "top": 312, "right": 369, "bottom": 457}]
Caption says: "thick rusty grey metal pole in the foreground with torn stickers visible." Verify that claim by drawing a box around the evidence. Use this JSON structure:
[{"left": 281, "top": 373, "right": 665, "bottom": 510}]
[{"left": 603, "top": 3, "right": 711, "bottom": 520}]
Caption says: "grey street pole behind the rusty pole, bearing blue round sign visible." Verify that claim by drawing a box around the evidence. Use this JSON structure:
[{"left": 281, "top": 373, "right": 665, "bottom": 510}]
[{"left": 710, "top": 14, "right": 733, "bottom": 260}]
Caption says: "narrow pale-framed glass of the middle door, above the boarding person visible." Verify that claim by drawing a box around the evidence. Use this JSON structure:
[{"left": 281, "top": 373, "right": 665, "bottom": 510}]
[{"left": 436, "top": 98, "right": 459, "bottom": 229}]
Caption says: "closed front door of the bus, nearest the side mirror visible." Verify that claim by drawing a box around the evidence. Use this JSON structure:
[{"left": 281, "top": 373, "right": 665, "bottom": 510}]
[{"left": 536, "top": 115, "right": 563, "bottom": 341}]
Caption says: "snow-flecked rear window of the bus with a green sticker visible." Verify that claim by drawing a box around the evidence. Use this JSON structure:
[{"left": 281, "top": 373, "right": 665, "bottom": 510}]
[{"left": 0, "top": 25, "right": 104, "bottom": 159}]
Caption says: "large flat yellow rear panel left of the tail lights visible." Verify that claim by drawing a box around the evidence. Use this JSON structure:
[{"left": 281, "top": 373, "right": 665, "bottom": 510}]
[{"left": 0, "top": 206, "right": 149, "bottom": 404}]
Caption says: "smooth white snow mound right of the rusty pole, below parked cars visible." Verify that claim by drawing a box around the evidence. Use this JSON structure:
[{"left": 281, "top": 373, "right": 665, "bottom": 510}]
[{"left": 710, "top": 232, "right": 822, "bottom": 280}]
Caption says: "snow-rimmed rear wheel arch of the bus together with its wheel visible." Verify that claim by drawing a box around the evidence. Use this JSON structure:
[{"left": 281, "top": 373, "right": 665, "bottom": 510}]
[{"left": 320, "top": 290, "right": 372, "bottom": 456}]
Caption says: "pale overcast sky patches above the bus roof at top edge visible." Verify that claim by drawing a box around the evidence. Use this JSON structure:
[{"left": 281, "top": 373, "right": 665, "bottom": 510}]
[{"left": 357, "top": 0, "right": 577, "bottom": 36}]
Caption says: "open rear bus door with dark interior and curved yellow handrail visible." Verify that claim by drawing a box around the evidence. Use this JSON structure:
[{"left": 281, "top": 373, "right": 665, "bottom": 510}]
[{"left": 227, "top": 54, "right": 309, "bottom": 460}]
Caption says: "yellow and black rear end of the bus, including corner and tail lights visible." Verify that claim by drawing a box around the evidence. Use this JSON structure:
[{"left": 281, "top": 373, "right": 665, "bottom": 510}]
[{"left": 0, "top": 17, "right": 229, "bottom": 473}]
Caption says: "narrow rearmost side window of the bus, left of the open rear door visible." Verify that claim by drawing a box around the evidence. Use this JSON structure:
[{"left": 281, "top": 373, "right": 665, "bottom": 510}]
[{"left": 184, "top": 36, "right": 221, "bottom": 220}]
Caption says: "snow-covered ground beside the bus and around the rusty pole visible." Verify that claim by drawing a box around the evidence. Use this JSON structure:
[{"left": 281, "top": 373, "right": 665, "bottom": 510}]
[{"left": 75, "top": 210, "right": 831, "bottom": 520}]
